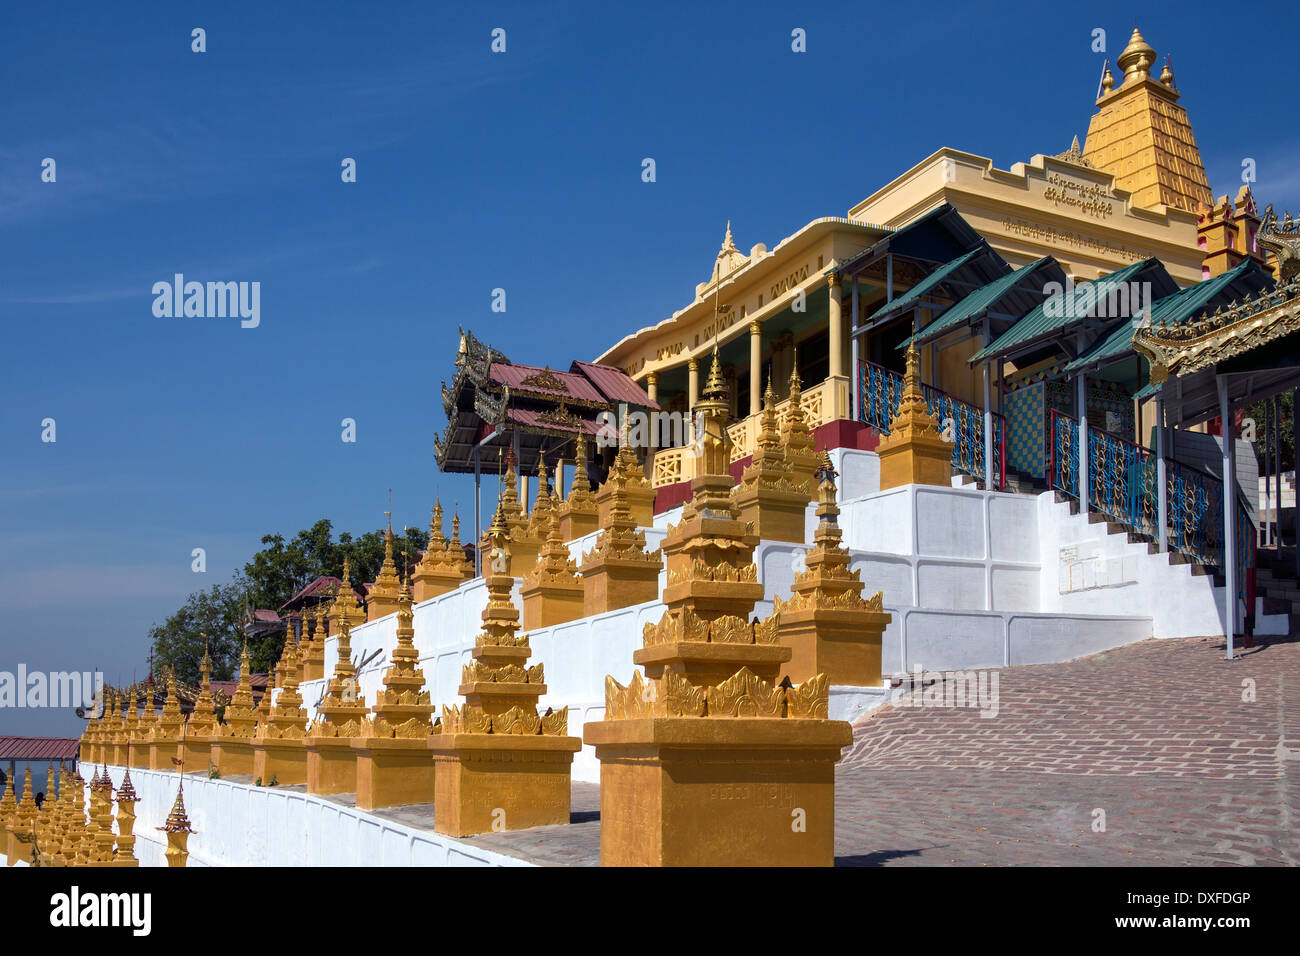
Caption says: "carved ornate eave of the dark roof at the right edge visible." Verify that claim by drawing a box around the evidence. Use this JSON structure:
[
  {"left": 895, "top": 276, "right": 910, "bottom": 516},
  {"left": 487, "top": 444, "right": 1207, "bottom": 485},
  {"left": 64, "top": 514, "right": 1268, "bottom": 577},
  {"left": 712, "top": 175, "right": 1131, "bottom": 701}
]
[{"left": 1132, "top": 278, "right": 1300, "bottom": 385}]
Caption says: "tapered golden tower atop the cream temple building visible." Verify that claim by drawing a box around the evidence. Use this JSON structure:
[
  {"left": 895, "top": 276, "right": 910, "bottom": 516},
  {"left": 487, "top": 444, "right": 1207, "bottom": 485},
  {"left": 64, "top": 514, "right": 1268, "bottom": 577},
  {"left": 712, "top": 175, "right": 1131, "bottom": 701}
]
[{"left": 1083, "top": 27, "right": 1214, "bottom": 212}]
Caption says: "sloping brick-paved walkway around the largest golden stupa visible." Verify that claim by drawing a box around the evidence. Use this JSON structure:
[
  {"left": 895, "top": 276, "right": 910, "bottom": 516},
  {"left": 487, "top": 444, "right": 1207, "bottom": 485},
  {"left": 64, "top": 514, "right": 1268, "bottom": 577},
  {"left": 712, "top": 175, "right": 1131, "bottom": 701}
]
[{"left": 462, "top": 639, "right": 1300, "bottom": 866}]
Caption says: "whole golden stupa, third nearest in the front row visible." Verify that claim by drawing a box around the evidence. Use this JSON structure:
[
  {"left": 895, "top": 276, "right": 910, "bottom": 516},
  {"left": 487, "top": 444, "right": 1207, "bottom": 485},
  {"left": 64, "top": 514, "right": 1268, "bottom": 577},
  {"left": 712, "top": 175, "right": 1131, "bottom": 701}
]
[{"left": 352, "top": 572, "right": 434, "bottom": 810}]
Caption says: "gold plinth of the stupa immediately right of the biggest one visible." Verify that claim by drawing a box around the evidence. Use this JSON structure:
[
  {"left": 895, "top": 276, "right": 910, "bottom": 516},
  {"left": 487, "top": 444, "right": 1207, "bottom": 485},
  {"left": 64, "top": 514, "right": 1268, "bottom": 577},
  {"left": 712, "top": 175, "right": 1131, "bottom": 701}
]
[{"left": 777, "top": 609, "right": 893, "bottom": 687}]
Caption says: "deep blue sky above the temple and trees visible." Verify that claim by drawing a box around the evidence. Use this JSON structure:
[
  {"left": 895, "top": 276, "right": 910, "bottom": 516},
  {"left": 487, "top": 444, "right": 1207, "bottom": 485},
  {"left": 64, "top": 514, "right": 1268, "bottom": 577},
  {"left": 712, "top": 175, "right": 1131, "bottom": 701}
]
[{"left": 0, "top": 3, "right": 1300, "bottom": 734}]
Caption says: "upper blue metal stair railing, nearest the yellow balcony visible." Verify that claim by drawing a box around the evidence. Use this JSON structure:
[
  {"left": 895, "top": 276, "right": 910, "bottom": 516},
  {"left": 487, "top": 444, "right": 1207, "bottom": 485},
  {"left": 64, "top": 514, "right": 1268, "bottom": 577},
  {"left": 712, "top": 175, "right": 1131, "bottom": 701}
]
[{"left": 858, "top": 360, "right": 1006, "bottom": 489}]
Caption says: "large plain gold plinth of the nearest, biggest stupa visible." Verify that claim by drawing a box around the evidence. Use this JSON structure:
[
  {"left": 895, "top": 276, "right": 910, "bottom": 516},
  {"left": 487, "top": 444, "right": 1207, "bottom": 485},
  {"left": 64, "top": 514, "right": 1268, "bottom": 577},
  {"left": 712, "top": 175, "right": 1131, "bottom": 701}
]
[{"left": 582, "top": 717, "right": 853, "bottom": 866}]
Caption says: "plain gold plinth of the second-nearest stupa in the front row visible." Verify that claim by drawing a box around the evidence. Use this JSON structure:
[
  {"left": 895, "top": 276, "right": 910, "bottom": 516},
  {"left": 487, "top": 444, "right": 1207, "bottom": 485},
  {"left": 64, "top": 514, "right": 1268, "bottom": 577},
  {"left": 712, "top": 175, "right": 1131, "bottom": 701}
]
[{"left": 429, "top": 734, "right": 582, "bottom": 836}]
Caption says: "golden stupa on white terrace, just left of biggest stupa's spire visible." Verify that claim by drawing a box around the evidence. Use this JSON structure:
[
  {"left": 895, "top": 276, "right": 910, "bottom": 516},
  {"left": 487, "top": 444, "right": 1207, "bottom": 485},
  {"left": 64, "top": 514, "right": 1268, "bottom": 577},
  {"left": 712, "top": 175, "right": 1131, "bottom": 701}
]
[{"left": 579, "top": 442, "right": 663, "bottom": 615}]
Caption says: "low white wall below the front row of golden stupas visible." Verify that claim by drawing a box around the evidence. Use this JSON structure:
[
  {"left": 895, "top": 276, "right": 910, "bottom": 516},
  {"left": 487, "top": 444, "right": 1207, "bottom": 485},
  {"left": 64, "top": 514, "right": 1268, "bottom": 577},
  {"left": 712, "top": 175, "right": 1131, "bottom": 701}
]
[{"left": 83, "top": 766, "right": 529, "bottom": 866}]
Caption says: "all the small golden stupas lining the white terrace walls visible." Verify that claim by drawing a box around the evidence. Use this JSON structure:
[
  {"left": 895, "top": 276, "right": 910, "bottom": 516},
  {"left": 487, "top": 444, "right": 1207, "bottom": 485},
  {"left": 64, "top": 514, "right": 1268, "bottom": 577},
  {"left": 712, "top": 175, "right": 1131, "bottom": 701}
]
[{"left": 12, "top": 352, "right": 950, "bottom": 865}]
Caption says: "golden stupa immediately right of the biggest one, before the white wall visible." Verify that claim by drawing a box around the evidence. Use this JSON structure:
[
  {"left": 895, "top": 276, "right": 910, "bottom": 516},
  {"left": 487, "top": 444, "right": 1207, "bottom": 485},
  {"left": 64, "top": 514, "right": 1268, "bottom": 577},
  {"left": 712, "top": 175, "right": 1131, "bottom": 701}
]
[{"left": 775, "top": 453, "right": 892, "bottom": 687}]
